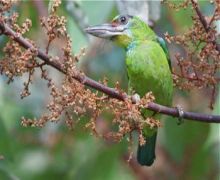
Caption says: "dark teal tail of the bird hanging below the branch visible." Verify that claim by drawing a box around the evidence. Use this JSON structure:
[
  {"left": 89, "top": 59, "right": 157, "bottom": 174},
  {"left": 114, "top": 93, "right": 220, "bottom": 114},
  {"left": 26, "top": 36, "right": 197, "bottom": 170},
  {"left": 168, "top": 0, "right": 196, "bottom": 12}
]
[{"left": 137, "top": 132, "right": 157, "bottom": 166}]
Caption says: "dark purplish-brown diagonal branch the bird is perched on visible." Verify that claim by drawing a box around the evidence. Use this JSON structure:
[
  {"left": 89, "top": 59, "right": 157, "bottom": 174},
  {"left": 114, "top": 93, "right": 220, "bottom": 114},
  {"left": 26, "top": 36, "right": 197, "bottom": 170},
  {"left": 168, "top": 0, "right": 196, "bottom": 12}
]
[{"left": 0, "top": 22, "right": 220, "bottom": 123}]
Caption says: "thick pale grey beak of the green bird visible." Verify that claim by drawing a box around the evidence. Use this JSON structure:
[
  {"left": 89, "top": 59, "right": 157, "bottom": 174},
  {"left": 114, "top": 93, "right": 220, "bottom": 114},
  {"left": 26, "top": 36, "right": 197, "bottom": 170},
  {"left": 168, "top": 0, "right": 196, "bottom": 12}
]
[{"left": 85, "top": 24, "right": 126, "bottom": 39}]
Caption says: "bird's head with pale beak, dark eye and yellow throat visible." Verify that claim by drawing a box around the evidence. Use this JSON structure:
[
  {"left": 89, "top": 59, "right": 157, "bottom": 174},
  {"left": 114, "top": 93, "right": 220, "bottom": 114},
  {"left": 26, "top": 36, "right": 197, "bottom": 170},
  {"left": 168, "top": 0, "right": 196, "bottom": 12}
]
[{"left": 85, "top": 15, "right": 156, "bottom": 48}]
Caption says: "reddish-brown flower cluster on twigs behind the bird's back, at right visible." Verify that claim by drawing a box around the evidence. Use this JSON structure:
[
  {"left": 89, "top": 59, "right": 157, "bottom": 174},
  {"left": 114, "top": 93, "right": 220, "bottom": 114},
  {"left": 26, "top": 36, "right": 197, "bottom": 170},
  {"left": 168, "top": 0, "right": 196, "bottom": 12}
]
[{"left": 165, "top": 0, "right": 220, "bottom": 108}]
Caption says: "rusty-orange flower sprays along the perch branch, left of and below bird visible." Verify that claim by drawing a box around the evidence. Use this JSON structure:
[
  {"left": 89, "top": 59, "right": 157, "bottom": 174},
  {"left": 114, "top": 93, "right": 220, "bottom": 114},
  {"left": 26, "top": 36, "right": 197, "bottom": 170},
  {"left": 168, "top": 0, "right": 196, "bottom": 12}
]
[{"left": 0, "top": 2, "right": 159, "bottom": 144}]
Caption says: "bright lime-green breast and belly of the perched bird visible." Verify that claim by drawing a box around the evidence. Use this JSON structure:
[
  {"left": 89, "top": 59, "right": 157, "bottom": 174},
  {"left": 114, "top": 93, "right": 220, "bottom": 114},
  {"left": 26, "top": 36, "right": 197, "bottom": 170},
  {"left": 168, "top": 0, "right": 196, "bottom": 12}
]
[{"left": 126, "top": 41, "right": 173, "bottom": 105}]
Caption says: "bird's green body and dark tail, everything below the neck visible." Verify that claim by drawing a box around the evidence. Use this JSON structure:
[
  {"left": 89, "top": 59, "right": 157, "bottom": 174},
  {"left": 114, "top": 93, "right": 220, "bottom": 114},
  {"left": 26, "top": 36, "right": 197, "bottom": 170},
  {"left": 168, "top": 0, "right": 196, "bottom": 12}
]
[{"left": 126, "top": 40, "right": 172, "bottom": 166}]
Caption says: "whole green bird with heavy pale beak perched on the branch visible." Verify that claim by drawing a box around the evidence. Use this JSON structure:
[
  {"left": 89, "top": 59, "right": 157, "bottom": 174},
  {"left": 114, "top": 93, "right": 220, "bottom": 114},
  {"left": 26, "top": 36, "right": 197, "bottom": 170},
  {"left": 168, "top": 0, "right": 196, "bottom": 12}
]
[{"left": 85, "top": 15, "right": 173, "bottom": 166}]
